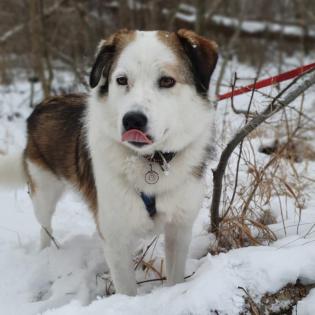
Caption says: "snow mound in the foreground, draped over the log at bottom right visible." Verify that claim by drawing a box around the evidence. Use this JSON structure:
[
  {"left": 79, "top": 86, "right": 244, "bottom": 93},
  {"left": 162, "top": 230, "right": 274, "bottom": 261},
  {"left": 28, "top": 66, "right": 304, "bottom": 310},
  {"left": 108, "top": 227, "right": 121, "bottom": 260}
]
[{"left": 45, "top": 245, "right": 315, "bottom": 315}]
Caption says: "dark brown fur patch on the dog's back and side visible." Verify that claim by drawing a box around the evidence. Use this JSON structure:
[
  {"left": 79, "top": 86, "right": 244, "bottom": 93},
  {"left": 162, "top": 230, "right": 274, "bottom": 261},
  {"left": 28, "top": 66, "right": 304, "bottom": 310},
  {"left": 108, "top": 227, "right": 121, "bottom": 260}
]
[{"left": 25, "top": 94, "right": 97, "bottom": 215}]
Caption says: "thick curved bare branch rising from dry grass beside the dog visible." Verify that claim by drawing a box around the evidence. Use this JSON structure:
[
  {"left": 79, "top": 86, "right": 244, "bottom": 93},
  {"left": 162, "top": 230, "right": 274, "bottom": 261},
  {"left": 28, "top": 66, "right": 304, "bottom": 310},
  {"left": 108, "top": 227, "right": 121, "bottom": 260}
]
[{"left": 210, "top": 70, "right": 315, "bottom": 234}]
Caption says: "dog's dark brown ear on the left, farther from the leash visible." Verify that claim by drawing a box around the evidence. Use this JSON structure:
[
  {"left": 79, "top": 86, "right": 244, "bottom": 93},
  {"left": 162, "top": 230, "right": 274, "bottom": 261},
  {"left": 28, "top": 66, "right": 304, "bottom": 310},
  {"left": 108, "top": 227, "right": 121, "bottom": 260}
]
[{"left": 90, "top": 29, "right": 131, "bottom": 91}]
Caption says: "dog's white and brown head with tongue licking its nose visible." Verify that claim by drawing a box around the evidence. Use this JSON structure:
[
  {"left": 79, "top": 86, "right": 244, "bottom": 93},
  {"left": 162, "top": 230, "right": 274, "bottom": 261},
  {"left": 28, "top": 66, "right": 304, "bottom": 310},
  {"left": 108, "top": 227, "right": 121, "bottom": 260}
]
[{"left": 90, "top": 29, "right": 218, "bottom": 154}]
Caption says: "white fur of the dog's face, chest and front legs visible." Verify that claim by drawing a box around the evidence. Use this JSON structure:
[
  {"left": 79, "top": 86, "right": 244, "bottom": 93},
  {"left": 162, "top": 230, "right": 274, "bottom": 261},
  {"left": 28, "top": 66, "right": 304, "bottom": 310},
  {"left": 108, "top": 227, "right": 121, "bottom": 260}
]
[{"left": 86, "top": 32, "right": 215, "bottom": 295}]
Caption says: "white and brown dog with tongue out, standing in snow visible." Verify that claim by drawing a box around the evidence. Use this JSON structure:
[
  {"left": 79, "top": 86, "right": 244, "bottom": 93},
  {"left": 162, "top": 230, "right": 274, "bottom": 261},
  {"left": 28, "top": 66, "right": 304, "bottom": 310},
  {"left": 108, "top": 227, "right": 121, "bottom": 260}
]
[{"left": 0, "top": 29, "right": 218, "bottom": 296}]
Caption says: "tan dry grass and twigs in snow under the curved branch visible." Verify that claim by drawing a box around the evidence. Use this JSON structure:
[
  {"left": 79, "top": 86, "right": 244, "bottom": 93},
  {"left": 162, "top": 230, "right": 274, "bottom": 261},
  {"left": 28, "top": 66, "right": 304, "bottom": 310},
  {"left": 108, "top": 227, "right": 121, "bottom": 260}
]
[{"left": 210, "top": 84, "right": 315, "bottom": 253}]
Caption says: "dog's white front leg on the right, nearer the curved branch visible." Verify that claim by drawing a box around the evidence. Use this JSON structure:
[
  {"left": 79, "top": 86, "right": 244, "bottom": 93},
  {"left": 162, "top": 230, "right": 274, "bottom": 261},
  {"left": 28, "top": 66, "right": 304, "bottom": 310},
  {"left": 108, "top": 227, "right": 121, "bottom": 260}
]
[{"left": 165, "top": 223, "right": 192, "bottom": 285}]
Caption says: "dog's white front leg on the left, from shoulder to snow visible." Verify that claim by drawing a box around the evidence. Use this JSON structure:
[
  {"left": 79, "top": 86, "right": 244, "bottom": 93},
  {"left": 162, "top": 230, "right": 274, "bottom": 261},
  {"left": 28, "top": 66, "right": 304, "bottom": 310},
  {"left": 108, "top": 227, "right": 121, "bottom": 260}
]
[{"left": 96, "top": 177, "right": 137, "bottom": 296}]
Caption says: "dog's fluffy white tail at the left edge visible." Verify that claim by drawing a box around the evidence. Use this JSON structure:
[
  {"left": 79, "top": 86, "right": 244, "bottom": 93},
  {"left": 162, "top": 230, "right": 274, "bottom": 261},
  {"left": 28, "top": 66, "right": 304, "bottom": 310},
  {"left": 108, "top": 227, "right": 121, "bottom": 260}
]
[{"left": 0, "top": 152, "right": 27, "bottom": 188}]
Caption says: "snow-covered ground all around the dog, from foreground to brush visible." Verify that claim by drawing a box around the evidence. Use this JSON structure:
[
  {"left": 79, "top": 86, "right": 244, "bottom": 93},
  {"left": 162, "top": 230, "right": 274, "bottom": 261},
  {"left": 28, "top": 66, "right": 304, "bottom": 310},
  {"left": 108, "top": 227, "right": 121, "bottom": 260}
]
[{"left": 0, "top": 63, "right": 315, "bottom": 315}]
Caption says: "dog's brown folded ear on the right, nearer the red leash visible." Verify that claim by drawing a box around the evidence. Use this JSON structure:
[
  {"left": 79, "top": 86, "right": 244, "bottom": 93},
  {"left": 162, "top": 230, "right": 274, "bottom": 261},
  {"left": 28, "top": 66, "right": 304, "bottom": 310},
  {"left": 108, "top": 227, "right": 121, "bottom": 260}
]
[{"left": 176, "top": 29, "right": 218, "bottom": 95}]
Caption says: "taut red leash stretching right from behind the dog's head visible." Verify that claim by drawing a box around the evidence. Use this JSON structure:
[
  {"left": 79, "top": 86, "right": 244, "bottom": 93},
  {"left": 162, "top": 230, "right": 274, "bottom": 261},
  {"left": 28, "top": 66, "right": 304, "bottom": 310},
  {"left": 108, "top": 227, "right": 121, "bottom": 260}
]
[{"left": 217, "top": 63, "right": 315, "bottom": 101}]
